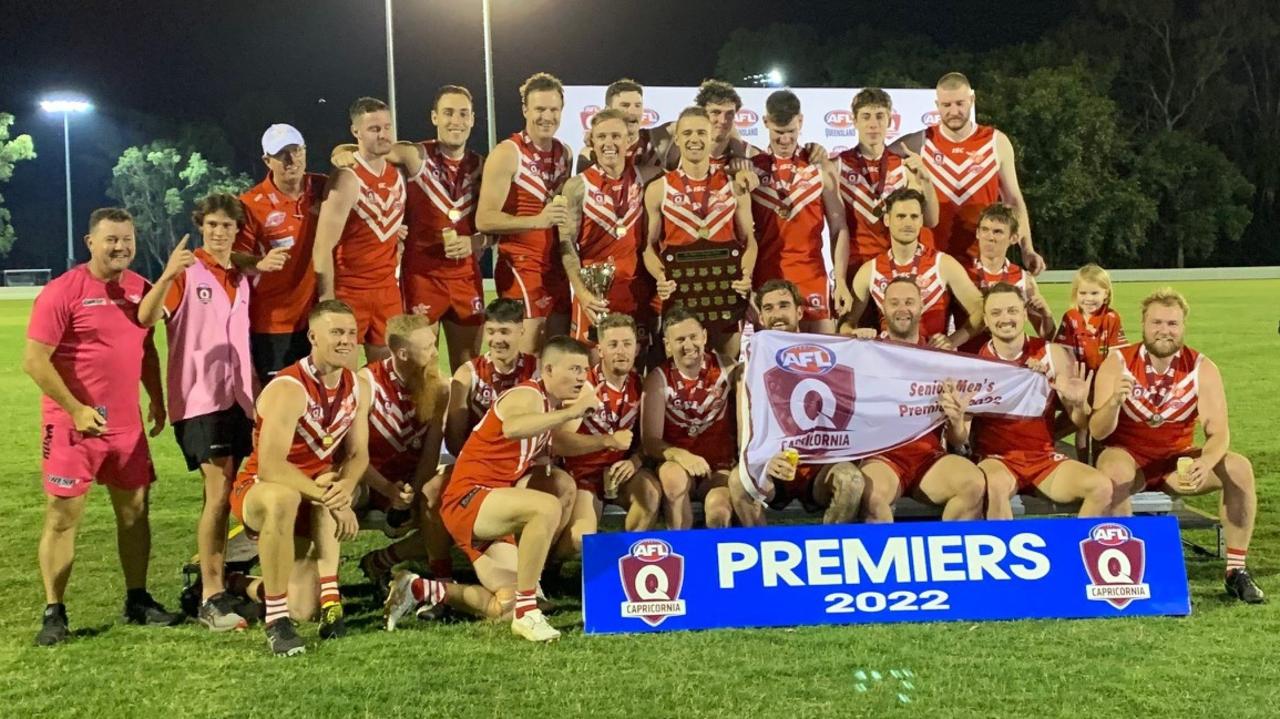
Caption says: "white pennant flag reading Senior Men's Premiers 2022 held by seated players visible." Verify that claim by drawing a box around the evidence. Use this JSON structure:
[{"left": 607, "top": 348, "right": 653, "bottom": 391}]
[{"left": 739, "top": 330, "right": 1048, "bottom": 499}]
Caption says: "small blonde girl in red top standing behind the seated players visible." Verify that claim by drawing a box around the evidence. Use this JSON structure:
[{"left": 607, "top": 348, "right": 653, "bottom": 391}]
[{"left": 1053, "top": 262, "right": 1128, "bottom": 462}]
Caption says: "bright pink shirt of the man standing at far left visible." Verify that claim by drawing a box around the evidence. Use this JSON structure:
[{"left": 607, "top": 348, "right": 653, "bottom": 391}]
[{"left": 27, "top": 265, "right": 150, "bottom": 429}]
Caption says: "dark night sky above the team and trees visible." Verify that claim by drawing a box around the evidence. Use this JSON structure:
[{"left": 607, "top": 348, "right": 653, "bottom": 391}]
[{"left": 0, "top": 0, "right": 1068, "bottom": 271}]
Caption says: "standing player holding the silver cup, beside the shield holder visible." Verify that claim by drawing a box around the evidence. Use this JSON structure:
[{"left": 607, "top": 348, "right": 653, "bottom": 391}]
[{"left": 559, "top": 109, "right": 658, "bottom": 349}]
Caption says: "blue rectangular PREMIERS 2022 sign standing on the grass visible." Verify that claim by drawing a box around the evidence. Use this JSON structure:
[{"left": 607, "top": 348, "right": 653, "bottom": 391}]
[{"left": 582, "top": 517, "right": 1190, "bottom": 633}]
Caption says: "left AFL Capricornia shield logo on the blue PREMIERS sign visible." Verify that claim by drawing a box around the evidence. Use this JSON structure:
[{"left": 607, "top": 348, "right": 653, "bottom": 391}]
[{"left": 618, "top": 539, "right": 685, "bottom": 627}]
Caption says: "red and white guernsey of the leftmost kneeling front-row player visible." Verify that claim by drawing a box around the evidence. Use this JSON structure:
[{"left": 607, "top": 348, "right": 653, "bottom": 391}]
[{"left": 236, "top": 357, "right": 360, "bottom": 484}]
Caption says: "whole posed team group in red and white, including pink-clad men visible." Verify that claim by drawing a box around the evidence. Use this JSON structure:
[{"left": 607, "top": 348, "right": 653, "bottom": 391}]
[{"left": 24, "top": 73, "right": 1263, "bottom": 655}]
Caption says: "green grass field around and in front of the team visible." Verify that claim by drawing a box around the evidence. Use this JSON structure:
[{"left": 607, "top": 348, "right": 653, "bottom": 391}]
[{"left": 0, "top": 281, "right": 1280, "bottom": 718}]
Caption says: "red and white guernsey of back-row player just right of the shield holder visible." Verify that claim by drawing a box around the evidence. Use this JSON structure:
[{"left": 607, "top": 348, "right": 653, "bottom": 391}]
[{"left": 751, "top": 152, "right": 826, "bottom": 284}]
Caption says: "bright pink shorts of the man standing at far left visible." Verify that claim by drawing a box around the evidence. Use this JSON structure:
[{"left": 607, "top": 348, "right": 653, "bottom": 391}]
[{"left": 41, "top": 425, "right": 156, "bottom": 498}]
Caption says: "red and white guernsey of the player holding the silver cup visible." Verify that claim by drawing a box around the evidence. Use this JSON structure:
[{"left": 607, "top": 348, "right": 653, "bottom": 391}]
[{"left": 577, "top": 162, "right": 644, "bottom": 287}]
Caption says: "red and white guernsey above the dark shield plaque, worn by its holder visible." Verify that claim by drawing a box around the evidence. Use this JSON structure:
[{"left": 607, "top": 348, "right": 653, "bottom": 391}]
[{"left": 662, "top": 166, "right": 741, "bottom": 248}]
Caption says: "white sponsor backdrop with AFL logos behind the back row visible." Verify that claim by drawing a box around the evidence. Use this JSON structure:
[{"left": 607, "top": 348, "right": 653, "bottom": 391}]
[{"left": 557, "top": 84, "right": 937, "bottom": 154}]
